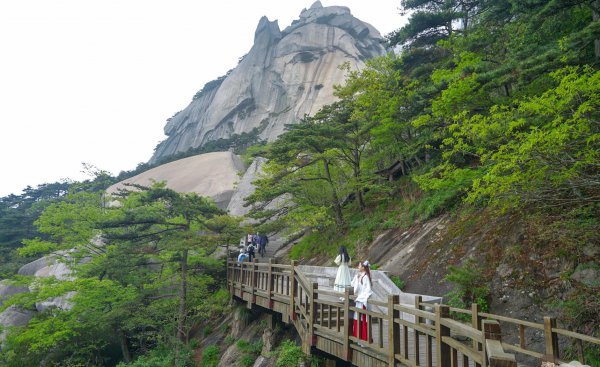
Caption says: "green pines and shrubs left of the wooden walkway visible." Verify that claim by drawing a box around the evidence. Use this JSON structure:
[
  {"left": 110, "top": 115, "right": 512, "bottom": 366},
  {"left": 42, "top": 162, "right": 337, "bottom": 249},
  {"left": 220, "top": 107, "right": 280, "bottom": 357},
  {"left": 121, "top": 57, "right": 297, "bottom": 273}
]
[{"left": 0, "top": 184, "right": 237, "bottom": 366}]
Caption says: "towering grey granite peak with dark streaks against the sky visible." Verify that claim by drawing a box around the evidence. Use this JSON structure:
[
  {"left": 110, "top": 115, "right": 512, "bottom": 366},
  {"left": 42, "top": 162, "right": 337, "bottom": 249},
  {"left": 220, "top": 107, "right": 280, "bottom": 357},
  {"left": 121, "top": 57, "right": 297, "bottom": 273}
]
[{"left": 150, "top": 1, "right": 385, "bottom": 163}]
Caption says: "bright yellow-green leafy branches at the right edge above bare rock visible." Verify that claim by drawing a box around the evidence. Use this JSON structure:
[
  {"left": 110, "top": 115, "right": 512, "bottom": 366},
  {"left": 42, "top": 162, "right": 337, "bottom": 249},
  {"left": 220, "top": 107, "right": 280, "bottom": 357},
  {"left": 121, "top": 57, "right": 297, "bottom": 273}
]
[{"left": 469, "top": 67, "right": 600, "bottom": 208}]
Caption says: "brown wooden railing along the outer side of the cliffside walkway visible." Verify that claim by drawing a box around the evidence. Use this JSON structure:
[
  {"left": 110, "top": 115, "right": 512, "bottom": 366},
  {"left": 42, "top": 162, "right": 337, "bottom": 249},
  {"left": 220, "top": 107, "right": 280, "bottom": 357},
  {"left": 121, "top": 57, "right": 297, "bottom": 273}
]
[{"left": 227, "top": 260, "right": 600, "bottom": 367}]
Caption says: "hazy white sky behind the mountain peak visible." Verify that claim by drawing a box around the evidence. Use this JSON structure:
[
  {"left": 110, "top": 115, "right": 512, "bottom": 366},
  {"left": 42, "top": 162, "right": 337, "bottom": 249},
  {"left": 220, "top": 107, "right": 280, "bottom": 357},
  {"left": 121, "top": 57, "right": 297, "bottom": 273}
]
[{"left": 0, "top": 0, "right": 404, "bottom": 196}]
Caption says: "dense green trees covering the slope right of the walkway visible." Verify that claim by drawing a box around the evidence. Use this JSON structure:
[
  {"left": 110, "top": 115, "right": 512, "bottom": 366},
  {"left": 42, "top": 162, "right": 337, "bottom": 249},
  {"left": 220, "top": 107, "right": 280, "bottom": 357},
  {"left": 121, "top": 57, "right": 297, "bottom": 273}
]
[{"left": 243, "top": 1, "right": 600, "bottom": 358}]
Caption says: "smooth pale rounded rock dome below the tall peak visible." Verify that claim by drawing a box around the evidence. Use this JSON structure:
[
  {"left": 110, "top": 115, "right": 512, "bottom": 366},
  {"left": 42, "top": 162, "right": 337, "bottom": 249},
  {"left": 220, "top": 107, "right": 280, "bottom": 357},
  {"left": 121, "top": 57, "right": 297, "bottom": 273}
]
[{"left": 107, "top": 152, "right": 244, "bottom": 209}]
